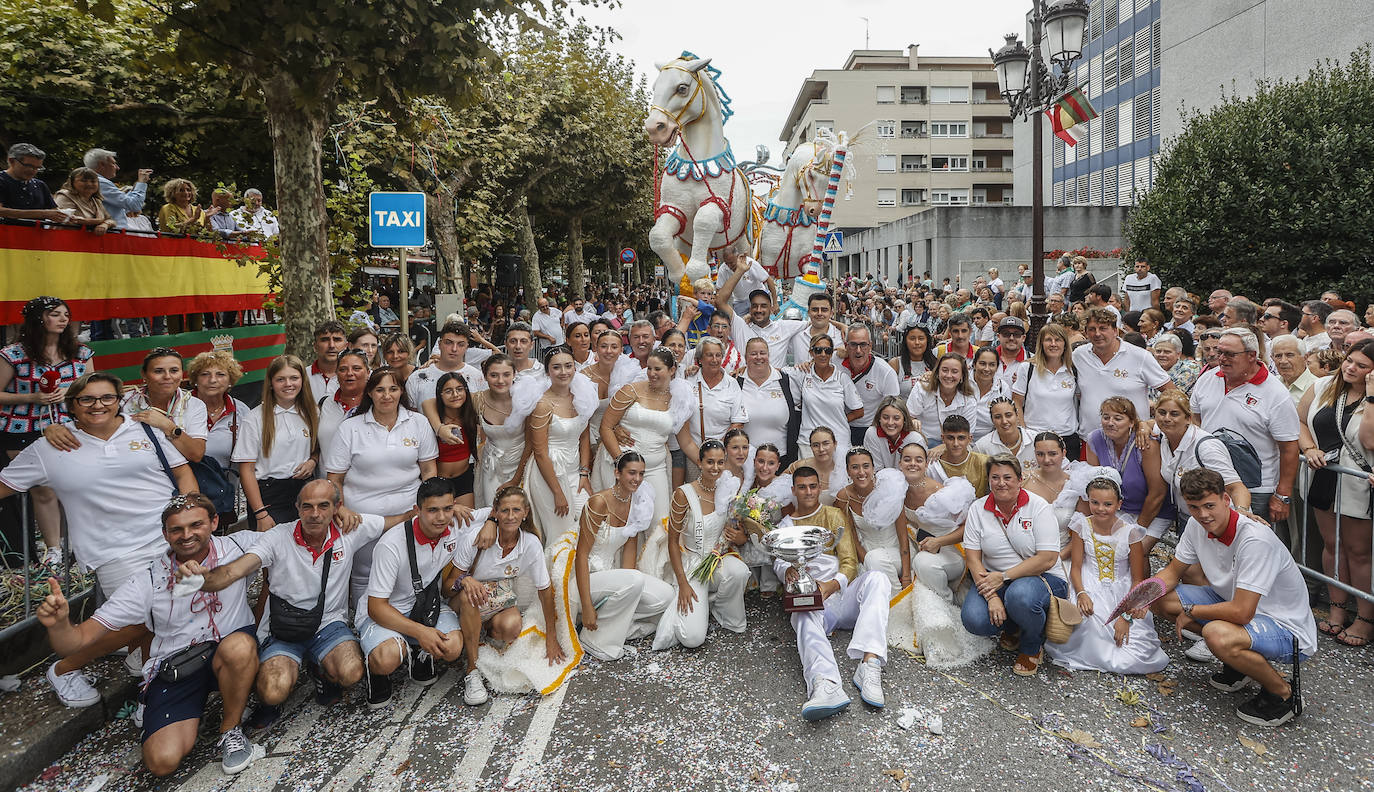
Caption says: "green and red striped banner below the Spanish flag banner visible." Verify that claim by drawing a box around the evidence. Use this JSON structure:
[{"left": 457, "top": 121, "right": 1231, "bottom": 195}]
[{"left": 91, "top": 325, "right": 286, "bottom": 385}]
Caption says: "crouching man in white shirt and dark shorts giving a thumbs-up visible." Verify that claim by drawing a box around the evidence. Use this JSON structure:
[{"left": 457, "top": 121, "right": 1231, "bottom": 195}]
[{"left": 37, "top": 492, "right": 261, "bottom": 776}]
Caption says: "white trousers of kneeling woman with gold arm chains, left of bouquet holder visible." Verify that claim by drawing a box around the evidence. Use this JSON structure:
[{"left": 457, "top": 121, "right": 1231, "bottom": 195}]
[{"left": 577, "top": 569, "right": 673, "bottom": 660}]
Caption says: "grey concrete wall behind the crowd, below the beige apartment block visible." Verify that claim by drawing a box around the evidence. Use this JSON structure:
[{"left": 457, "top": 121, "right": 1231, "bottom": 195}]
[{"left": 829, "top": 206, "right": 1127, "bottom": 282}]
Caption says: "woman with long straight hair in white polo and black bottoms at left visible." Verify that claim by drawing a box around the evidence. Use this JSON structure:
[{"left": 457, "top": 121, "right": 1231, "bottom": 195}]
[{"left": 234, "top": 355, "right": 322, "bottom": 531}]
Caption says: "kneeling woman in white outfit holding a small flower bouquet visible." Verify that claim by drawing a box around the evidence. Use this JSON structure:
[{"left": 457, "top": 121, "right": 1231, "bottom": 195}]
[{"left": 654, "top": 440, "right": 749, "bottom": 649}]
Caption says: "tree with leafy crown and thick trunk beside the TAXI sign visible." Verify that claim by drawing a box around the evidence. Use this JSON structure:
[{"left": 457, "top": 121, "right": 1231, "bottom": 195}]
[{"left": 74, "top": 0, "right": 567, "bottom": 355}]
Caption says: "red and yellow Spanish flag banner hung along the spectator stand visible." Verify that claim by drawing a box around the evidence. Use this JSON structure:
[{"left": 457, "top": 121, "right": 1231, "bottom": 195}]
[{"left": 0, "top": 226, "right": 268, "bottom": 325}]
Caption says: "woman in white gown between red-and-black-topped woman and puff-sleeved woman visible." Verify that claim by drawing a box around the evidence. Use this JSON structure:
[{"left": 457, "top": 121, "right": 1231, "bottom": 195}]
[{"left": 473, "top": 352, "right": 525, "bottom": 506}]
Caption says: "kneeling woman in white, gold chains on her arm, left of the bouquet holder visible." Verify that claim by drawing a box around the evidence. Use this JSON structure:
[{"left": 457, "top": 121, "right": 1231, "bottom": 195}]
[{"left": 574, "top": 451, "right": 673, "bottom": 660}]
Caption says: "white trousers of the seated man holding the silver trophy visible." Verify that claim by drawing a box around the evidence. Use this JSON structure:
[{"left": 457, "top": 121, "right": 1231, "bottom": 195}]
[{"left": 774, "top": 556, "right": 892, "bottom": 699}]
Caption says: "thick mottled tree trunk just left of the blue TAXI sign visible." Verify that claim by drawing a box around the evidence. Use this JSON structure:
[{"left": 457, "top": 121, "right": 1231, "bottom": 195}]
[{"left": 258, "top": 73, "right": 334, "bottom": 360}]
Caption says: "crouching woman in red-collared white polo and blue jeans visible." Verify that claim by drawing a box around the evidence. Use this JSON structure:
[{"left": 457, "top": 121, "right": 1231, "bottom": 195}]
[{"left": 962, "top": 454, "right": 1069, "bottom": 677}]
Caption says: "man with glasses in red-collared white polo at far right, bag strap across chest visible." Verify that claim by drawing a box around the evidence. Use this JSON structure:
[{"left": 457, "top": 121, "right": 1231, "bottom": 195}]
[{"left": 1193, "top": 327, "right": 1298, "bottom": 524}]
